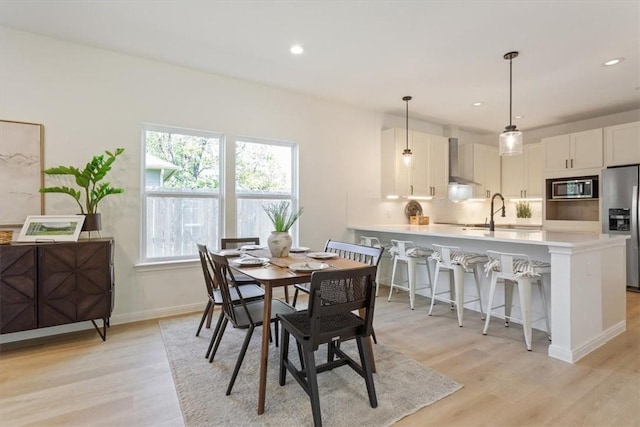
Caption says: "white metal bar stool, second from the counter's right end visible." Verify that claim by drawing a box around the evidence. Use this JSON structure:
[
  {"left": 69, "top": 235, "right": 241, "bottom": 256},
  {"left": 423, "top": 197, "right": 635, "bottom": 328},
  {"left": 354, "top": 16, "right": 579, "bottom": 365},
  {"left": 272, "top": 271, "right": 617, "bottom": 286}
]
[{"left": 429, "top": 245, "right": 488, "bottom": 327}]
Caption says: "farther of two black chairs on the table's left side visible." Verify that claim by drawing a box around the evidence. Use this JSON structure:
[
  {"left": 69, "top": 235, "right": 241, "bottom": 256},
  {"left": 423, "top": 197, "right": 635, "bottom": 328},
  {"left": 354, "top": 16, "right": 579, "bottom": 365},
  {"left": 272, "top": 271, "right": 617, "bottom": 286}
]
[{"left": 196, "top": 243, "right": 264, "bottom": 348}]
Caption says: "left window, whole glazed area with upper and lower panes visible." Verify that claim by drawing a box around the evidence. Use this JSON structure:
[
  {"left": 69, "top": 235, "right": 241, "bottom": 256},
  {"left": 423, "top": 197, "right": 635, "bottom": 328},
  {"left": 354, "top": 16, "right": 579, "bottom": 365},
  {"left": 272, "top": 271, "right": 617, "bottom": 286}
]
[{"left": 141, "top": 125, "right": 223, "bottom": 262}]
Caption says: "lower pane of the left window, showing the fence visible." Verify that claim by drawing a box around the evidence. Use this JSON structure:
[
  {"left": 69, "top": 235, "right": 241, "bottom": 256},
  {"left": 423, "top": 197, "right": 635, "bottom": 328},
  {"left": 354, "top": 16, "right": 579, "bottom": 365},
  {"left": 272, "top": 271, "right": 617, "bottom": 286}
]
[{"left": 145, "top": 197, "right": 219, "bottom": 259}]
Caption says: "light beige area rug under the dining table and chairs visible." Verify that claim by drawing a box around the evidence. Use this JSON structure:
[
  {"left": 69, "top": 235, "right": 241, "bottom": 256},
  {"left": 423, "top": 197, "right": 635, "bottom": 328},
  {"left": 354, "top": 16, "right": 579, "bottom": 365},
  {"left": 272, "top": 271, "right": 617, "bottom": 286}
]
[{"left": 160, "top": 312, "right": 462, "bottom": 427}]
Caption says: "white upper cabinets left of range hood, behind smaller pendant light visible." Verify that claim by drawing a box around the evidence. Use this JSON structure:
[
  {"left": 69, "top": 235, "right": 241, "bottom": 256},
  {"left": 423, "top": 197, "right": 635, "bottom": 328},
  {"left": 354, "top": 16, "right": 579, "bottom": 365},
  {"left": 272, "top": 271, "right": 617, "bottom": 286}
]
[{"left": 380, "top": 129, "right": 449, "bottom": 197}]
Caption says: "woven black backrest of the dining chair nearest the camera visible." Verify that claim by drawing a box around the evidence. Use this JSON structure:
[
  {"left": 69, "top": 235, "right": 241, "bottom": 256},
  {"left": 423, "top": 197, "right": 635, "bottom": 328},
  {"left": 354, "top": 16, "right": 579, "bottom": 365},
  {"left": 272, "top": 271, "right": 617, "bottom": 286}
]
[{"left": 307, "top": 266, "right": 376, "bottom": 349}]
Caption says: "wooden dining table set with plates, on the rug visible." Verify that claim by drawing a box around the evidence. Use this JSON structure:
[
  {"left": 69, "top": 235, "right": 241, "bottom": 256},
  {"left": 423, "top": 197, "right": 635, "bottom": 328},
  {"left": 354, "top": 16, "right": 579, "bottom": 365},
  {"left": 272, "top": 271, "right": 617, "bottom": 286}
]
[{"left": 229, "top": 249, "right": 375, "bottom": 415}]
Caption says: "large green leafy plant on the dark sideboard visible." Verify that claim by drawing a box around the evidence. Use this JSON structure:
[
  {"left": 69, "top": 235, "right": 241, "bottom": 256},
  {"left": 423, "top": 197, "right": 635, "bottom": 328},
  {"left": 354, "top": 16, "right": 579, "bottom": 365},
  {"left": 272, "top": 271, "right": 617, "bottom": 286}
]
[{"left": 40, "top": 148, "right": 124, "bottom": 214}]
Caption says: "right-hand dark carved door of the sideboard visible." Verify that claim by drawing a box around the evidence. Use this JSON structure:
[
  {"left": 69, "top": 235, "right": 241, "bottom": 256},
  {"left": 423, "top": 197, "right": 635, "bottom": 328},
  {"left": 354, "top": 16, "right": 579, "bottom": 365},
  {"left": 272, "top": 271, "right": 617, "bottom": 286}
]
[{"left": 38, "top": 241, "right": 113, "bottom": 327}]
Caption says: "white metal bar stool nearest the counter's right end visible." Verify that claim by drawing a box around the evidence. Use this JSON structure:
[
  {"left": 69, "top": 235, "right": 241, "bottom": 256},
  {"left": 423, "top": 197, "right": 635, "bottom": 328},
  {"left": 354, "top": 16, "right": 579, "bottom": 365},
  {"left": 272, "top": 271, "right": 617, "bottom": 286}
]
[{"left": 482, "top": 251, "right": 551, "bottom": 351}]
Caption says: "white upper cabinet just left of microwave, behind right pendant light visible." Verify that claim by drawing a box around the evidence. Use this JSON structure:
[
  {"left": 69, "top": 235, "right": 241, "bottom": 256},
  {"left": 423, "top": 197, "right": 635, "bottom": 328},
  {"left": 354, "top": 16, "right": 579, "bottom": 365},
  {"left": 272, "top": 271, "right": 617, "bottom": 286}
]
[{"left": 501, "top": 143, "right": 543, "bottom": 198}]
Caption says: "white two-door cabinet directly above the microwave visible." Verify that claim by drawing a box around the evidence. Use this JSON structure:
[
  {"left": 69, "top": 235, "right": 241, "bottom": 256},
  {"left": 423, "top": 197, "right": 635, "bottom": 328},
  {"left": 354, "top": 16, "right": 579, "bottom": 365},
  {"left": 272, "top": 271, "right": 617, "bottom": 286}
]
[{"left": 542, "top": 128, "right": 603, "bottom": 173}]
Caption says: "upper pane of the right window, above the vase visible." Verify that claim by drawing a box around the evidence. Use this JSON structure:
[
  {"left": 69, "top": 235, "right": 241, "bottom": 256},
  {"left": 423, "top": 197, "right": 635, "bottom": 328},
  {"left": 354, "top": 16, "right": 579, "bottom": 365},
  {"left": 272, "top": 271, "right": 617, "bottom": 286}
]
[{"left": 236, "top": 141, "right": 293, "bottom": 194}]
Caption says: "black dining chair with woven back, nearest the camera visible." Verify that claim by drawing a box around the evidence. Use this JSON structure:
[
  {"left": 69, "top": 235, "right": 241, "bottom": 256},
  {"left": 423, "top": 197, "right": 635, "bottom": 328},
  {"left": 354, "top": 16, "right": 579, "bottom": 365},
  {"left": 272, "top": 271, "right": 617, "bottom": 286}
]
[{"left": 278, "top": 266, "right": 378, "bottom": 427}]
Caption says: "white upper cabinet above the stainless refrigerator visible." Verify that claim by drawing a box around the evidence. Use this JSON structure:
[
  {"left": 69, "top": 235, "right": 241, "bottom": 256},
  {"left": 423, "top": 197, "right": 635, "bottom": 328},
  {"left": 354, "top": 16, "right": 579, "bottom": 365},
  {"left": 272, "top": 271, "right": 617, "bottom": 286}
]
[{"left": 604, "top": 122, "right": 640, "bottom": 166}]
